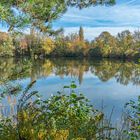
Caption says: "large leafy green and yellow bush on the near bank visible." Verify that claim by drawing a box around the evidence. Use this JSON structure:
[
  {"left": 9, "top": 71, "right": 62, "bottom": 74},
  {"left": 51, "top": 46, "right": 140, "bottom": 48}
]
[{"left": 0, "top": 82, "right": 112, "bottom": 140}]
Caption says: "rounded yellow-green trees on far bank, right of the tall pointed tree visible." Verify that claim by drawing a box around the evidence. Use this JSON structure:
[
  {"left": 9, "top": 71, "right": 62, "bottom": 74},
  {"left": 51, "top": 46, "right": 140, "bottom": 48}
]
[{"left": 89, "top": 30, "right": 140, "bottom": 59}]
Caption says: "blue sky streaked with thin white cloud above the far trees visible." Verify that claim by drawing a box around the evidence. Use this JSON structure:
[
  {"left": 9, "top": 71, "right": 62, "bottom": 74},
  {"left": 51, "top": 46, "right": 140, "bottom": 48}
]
[{"left": 53, "top": 0, "right": 140, "bottom": 40}]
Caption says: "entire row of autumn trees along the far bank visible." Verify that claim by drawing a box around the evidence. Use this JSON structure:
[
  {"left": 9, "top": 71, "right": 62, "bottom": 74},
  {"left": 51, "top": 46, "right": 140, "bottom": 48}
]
[{"left": 0, "top": 27, "right": 140, "bottom": 58}]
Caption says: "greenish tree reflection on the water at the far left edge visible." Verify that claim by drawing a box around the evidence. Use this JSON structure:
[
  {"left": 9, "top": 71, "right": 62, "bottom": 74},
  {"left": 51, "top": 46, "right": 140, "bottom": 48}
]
[{"left": 0, "top": 58, "right": 31, "bottom": 84}]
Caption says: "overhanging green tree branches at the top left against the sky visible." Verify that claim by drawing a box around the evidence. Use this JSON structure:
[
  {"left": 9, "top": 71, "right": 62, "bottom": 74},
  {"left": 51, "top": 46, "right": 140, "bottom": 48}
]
[{"left": 0, "top": 0, "right": 115, "bottom": 33}]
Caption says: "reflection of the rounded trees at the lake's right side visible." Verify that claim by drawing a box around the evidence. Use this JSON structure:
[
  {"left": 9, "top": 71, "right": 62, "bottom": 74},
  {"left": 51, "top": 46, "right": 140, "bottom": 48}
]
[{"left": 91, "top": 60, "right": 140, "bottom": 85}]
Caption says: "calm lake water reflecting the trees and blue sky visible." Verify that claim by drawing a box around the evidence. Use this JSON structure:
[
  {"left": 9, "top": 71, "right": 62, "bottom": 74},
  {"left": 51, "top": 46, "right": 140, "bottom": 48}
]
[{"left": 0, "top": 58, "right": 140, "bottom": 123}]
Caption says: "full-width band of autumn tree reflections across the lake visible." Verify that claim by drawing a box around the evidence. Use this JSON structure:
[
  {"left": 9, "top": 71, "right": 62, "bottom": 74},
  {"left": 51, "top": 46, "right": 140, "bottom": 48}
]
[{"left": 0, "top": 59, "right": 140, "bottom": 85}]
